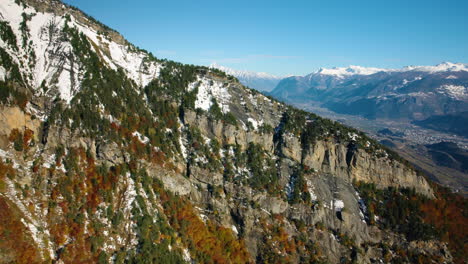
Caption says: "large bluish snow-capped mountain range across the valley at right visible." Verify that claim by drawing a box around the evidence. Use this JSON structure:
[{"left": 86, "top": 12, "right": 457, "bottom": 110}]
[{"left": 271, "top": 62, "right": 468, "bottom": 135}]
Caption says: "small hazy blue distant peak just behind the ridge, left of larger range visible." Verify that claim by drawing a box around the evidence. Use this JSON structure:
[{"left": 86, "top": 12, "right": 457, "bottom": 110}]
[{"left": 210, "top": 64, "right": 285, "bottom": 92}]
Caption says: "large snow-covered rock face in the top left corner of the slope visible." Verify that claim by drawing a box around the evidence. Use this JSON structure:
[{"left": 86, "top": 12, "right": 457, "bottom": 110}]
[{"left": 0, "top": 0, "right": 79, "bottom": 103}]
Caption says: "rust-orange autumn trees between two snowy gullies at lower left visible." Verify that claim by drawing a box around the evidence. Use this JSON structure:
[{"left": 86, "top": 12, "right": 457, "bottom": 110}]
[{"left": 47, "top": 148, "right": 120, "bottom": 263}]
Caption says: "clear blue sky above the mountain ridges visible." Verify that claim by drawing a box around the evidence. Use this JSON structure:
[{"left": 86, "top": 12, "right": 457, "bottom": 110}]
[{"left": 65, "top": 0, "right": 468, "bottom": 75}]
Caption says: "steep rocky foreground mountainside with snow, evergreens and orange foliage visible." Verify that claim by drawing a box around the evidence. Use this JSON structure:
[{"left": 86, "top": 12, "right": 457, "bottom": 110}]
[{"left": 0, "top": 0, "right": 464, "bottom": 263}]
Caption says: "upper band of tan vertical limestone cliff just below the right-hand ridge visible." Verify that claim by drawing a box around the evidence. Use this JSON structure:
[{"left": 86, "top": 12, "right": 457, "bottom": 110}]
[{"left": 185, "top": 108, "right": 433, "bottom": 197}]
